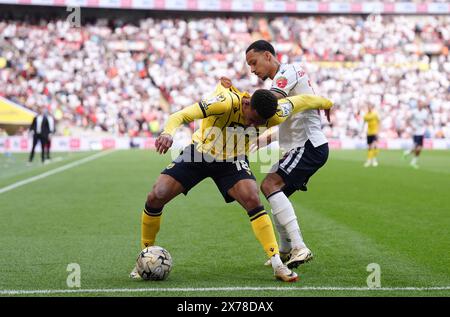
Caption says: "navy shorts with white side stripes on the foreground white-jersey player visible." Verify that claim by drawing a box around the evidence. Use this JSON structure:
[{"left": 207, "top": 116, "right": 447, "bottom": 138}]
[{"left": 275, "top": 140, "right": 329, "bottom": 197}]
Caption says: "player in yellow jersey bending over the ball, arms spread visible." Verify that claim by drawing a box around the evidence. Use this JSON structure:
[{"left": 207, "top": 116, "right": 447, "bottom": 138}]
[{"left": 130, "top": 79, "right": 332, "bottom": 282}]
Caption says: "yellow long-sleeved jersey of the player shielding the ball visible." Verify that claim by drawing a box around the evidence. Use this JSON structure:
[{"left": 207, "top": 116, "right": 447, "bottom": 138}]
[{"left": 163, "top": 84, "right": 332, "bottom": 160}]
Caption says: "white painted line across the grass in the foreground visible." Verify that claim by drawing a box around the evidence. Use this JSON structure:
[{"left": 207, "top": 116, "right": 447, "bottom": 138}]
[{"left": 0, "top": 286, "right": 450, "bottom": 295}]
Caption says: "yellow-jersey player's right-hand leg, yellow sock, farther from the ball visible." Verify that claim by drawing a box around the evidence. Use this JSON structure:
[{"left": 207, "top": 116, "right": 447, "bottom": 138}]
[{"left": 228, "top": 179, "right": 298, "bottom": 282}]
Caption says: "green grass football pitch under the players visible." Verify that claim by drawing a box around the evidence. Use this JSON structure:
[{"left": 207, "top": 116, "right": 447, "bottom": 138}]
[{"left": 0, "top": 150, "right": 450, "bottom": 297}]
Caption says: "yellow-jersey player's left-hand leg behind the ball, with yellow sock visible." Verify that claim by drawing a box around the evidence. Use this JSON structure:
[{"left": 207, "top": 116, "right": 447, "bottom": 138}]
[{"left": 130, "top": 174, "right": 184, "bottom": 279}]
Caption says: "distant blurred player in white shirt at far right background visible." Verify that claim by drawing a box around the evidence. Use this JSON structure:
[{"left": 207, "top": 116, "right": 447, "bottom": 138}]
[{"left": 403, "top": 102, "right": 430, "bottom": 169}]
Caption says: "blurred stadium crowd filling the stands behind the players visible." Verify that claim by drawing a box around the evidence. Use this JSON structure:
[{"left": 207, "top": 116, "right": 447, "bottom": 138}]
[{"left": 0, "top": 15, "right": 450, "bottom": 138}]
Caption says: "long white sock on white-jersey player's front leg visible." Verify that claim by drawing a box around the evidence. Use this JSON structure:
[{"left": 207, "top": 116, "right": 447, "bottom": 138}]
[{"left": 268, "top": 192, "right": 306, "bottom": 251}]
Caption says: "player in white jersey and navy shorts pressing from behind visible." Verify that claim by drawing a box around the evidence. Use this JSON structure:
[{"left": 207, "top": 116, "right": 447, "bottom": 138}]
[{"left": 246, "top": 40, "right": 329, "bottom": 268}]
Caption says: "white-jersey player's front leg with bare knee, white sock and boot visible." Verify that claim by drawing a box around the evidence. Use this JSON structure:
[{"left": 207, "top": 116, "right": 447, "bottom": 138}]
[{"left": 261, "top": 173, "right": 313, "bottom": 268}]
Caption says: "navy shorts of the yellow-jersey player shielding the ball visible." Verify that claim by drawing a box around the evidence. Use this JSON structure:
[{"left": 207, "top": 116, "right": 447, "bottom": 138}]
[{"left": 161, "top": 144, "right": 256, "bottom": 203}]
